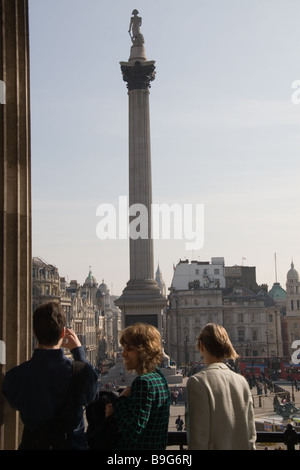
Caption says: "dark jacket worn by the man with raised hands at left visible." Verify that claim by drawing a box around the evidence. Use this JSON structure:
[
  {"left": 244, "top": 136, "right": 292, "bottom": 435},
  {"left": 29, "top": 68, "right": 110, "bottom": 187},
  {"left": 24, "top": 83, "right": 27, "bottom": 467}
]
[{"left": 2, "top": 346, "right": 98, "bottom": 449}]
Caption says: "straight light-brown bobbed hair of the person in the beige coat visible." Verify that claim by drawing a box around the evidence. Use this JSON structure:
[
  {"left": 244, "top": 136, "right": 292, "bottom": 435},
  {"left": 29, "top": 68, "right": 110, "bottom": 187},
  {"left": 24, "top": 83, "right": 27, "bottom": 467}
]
[{"left": 197, "top": 323, "right": 238, "bottom": 360}]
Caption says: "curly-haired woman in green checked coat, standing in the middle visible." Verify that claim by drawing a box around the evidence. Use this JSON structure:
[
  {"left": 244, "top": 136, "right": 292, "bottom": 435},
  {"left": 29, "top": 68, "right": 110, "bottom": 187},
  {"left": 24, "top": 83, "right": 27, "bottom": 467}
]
[{"left": 106, "top": 323, "right": 171, "bottom": 450}]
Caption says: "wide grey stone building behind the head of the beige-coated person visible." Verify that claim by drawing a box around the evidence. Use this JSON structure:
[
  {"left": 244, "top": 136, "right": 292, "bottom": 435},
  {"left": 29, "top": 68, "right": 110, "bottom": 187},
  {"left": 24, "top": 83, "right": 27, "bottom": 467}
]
[{"left": 166, "top": 258, "right": 283, "bottom": 364}]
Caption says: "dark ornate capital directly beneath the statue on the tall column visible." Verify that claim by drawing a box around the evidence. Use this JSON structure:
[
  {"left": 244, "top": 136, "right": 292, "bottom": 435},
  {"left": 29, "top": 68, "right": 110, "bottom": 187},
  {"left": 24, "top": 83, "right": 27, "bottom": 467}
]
[{"left": 121, "top": 61, "right": 155, "bottom": 91}]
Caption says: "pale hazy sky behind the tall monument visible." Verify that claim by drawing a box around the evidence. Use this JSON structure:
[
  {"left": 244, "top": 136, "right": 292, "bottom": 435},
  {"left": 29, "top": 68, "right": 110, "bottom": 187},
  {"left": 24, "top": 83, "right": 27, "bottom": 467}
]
[{"left": 29, "top": 0, "right": 300, "bottom": 295}]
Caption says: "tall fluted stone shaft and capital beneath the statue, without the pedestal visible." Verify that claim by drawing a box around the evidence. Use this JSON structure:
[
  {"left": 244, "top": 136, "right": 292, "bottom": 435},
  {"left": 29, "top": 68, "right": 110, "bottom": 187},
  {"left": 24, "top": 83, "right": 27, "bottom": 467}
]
[{"left": 121, "top": 62, "right": 155, "bottom": 281}]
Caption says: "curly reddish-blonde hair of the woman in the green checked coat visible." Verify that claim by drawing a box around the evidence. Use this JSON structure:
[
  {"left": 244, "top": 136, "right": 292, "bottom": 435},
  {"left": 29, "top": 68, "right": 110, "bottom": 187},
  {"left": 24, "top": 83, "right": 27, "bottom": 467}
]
[{"left": 120, "top": 323, "right": 163, "bottom": 375}]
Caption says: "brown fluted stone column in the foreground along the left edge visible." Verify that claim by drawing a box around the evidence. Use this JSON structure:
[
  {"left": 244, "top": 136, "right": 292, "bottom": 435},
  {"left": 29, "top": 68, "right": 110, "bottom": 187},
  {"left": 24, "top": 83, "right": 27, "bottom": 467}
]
[{"left": 0, "top": 0, "right": 32, "bottom": 450}]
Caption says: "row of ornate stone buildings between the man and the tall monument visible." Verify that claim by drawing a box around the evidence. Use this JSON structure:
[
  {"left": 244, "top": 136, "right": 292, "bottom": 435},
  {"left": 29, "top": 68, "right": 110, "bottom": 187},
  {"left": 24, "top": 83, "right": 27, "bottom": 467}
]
[{"left": 32, "top": 258, "right": 121, "bottom": 366}]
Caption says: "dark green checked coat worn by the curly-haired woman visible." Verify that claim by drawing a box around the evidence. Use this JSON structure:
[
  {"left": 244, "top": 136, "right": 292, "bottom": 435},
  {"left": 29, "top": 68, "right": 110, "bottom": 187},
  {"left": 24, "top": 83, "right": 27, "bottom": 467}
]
[{"left": 114, "top": 369, "right": 171, "bottom": 450}]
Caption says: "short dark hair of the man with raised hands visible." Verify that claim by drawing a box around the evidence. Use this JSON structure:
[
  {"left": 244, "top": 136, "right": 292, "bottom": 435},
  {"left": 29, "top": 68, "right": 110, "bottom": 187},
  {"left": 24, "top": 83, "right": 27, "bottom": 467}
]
[{"left": 33, "top": 302, "right": 66, "bottom": 346}]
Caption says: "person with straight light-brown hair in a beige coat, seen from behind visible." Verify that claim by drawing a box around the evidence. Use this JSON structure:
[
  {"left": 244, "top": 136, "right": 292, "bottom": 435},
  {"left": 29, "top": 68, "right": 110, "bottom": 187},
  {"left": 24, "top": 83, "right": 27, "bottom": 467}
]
[{"left": 186, "top": 323, "right": 256, "bottom": 450}]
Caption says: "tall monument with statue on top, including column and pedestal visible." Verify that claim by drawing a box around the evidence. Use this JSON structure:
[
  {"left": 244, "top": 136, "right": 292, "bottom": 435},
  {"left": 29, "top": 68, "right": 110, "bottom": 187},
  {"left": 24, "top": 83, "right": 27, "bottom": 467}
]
[{"left": 115, "top": 10, "right": 166, "bottom": 332}]
